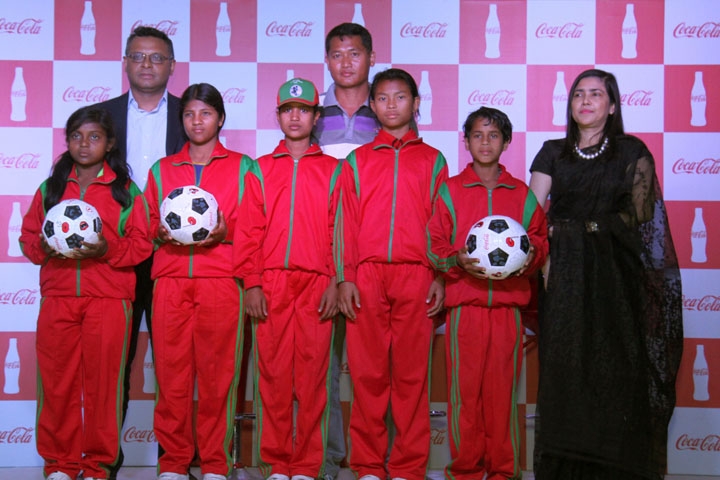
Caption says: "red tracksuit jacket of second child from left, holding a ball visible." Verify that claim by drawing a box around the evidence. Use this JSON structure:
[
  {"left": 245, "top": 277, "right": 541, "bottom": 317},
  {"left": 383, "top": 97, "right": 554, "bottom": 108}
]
[{"left": 145, "top": 142, "right": 257, "bottom": 279}]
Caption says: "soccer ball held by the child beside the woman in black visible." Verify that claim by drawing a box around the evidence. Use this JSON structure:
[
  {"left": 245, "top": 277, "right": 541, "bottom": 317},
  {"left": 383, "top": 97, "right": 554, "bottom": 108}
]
[{"left": 465, "top": 215, "right": 530, "bottom": 280}]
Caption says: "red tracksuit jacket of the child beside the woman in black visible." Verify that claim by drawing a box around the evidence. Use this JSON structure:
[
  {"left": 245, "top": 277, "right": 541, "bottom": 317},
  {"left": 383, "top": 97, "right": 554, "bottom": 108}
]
[{"left": 428, "top": 164, "right": 548, "bottom": 307}]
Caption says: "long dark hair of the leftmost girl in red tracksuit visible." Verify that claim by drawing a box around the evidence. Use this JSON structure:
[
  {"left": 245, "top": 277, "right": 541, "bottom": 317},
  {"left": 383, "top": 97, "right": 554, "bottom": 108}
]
[{"left": 44, "top": 106, "right": 131, "bottom": 211}]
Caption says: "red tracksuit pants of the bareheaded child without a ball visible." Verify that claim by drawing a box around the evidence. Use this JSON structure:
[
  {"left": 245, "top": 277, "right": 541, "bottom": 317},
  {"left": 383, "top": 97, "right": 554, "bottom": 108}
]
[{"left": 347, "top": 263, "right": 434, "bottom": 480}]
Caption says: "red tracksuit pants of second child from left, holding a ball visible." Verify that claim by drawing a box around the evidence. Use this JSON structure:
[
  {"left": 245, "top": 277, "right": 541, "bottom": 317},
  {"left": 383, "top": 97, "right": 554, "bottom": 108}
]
[{"left": 152, "top": 277, "right": 244, "bottom": 475}]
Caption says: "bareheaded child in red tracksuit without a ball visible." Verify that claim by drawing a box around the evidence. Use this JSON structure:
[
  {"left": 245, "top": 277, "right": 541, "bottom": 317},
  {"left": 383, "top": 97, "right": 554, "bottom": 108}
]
[{"left": 335, "top": 68, "right": 448, "bottom": 480}]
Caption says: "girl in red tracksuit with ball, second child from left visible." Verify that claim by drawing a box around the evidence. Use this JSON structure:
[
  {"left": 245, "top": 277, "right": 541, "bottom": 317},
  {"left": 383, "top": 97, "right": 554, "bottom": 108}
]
[{"left": 145, "top": 83, "right": 255, "bottom": 480}]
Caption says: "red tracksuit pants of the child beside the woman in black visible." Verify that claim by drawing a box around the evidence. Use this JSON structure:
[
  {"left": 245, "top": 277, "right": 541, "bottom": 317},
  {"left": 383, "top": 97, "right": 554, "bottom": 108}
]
[{"left": 445, "top": 305, "right": 523, "bottom": 480}]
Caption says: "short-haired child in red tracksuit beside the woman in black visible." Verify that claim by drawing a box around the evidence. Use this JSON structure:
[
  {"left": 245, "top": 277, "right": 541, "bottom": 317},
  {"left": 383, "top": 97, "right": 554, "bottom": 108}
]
[{"left": 428, "top": 107, "right": 548, "bottom": 480}]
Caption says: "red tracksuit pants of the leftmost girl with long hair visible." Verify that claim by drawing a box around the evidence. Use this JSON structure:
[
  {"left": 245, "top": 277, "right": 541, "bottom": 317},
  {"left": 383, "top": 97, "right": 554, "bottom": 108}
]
[{"left": 36, "top": 297, "right": 132, "bottom": 478}]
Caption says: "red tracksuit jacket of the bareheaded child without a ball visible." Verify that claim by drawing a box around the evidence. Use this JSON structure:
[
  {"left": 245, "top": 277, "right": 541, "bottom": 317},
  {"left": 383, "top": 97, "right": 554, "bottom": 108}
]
[{"left": 335, "top": 130, "right": 448, "bottom": 283}]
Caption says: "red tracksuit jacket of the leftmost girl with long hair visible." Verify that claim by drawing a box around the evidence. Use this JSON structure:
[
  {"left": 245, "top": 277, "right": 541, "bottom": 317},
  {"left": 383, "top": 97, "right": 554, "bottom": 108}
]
[{"left": 20, "top": 162, "right": 152, "bottom": 300}]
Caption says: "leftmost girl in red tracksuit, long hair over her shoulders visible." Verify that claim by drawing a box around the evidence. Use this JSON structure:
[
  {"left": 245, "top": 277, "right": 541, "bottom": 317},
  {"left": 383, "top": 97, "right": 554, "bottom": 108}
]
[{"left": 20, "top": 107, "right": 152, "bottom": 480}]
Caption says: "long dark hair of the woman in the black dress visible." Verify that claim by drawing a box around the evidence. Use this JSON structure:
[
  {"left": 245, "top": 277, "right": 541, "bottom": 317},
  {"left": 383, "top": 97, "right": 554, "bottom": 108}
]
[{"left": 563, "top": 68, "right": 625, "bottom": 156}]
